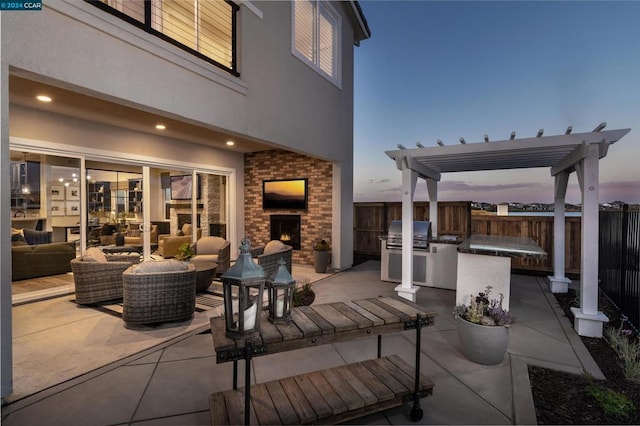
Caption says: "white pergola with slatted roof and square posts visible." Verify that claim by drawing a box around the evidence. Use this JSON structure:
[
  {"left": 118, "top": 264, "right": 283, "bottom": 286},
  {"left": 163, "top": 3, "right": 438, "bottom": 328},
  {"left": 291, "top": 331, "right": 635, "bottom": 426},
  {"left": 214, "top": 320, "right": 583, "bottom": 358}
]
[{"left": 386, "top": 123, "right": 631, "bottom": 337}]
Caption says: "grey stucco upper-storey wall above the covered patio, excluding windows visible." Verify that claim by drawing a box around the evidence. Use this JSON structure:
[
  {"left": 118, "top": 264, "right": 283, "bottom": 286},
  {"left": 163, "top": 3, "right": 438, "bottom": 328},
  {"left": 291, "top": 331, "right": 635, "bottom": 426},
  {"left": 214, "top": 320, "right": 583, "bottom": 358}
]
[{"left": 2, "top": 0, "right": 353, "bottom": 161}]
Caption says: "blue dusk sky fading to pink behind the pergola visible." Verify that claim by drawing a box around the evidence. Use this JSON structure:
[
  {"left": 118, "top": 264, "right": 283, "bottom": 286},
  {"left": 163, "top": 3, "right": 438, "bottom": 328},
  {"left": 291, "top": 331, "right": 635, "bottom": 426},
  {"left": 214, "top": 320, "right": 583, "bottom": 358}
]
[{"left": 354, "top": 0, "right": 640, "bottom": 203}]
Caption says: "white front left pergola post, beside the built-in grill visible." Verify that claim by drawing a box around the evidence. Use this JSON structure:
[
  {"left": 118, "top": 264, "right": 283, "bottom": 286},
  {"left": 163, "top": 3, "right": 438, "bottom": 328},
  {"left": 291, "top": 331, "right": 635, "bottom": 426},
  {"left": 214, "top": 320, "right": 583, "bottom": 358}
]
[{"left": 395, "top": 162, "right": 419, "bottom": 302}]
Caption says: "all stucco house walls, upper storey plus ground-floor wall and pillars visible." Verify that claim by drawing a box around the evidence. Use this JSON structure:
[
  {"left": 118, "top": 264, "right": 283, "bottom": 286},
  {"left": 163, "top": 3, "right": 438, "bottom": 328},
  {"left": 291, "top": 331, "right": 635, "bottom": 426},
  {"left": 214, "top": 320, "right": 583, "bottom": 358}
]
[{"left": 0, "top": 0, "right": 354, "bottom": 396}]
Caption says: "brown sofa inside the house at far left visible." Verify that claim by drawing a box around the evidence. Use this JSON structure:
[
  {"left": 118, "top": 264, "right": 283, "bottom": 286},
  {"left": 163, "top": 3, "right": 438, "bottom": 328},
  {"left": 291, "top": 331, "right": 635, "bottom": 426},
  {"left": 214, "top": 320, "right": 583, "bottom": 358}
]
[{"left": 11, "top": 228, "right": 76, "bottom": 281}]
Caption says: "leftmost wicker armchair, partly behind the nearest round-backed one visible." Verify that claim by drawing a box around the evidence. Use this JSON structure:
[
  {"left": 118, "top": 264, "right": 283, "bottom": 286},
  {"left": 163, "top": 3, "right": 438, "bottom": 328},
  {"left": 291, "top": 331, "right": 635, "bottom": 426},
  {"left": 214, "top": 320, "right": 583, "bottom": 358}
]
[{"left": 71, "top": 254, "right": 140, "bottom": 305}]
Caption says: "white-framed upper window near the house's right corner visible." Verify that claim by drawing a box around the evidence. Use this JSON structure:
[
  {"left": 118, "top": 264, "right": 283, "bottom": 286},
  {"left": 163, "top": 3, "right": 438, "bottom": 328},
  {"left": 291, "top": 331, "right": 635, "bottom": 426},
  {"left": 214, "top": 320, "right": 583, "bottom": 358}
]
[{"left": 292, "top": 0, "right": 341, "bottom": 86}]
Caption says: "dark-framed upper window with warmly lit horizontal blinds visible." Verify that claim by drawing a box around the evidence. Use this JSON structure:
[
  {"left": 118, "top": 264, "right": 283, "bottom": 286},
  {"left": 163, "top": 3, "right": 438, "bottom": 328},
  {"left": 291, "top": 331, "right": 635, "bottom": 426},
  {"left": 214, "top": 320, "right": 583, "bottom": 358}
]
[{"left": 87, "top": 0, "right": 239, "bottom": 76}]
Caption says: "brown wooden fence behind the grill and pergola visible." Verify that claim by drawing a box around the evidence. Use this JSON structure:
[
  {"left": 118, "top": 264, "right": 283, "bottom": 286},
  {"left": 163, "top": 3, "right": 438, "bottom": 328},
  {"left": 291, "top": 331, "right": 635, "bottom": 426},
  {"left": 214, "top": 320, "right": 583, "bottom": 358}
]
[{"left": 353, "top": 202, "right": 582, "bottom": 276}]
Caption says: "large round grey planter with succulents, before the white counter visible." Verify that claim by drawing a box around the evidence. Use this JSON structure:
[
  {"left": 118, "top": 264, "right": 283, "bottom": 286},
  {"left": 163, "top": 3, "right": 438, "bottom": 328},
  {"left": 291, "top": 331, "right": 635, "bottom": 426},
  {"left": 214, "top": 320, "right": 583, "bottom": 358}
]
[{"left": 454, "top": 286, "right": 515, "bottom": 365}]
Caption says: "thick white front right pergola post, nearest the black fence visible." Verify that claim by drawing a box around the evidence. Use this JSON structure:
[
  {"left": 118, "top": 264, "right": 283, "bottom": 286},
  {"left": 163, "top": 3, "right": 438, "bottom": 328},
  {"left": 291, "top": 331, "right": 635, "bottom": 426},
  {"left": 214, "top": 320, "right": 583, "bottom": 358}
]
[{"left": 571, "top": 144, "right": 609, "bottom": 338}]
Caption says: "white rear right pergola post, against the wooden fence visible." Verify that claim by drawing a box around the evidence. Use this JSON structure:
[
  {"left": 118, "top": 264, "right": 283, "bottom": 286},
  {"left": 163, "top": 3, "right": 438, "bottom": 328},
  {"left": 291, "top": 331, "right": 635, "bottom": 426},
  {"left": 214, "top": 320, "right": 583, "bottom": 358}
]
[{"left": 547, "top": 170, "right": 571, "bottom": 293}]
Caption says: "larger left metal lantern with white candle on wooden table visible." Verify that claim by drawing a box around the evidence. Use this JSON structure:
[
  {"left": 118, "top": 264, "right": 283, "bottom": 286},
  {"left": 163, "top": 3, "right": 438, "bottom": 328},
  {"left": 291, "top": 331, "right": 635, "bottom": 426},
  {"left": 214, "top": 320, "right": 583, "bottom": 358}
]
[{"left": 221, "top": 238, "right": 265, "bottom": 339}]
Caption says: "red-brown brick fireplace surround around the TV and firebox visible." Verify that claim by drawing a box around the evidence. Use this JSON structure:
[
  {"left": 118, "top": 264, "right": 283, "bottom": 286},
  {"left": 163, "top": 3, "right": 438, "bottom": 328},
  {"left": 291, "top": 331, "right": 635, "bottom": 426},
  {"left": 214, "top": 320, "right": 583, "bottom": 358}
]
[{"left": 244, "top": 150, "right": 332, "bottom": 265}]
